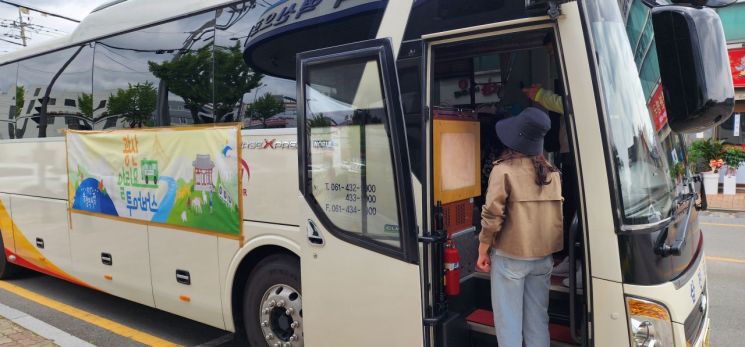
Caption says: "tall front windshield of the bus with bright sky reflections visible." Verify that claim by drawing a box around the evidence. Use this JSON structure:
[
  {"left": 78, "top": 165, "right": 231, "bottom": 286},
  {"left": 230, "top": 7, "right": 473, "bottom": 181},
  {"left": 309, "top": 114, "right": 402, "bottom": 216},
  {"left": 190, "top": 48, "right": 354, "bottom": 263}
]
[{"left": 586, "top": 0, "right": 673, "bottom": 225}]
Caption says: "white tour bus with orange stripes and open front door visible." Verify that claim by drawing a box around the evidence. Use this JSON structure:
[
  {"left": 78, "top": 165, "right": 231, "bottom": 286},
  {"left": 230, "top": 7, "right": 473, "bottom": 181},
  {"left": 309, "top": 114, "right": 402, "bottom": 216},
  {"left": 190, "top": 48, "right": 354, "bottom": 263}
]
[{"left": 0, "top": 0, "right": 724, "bottom": 346}]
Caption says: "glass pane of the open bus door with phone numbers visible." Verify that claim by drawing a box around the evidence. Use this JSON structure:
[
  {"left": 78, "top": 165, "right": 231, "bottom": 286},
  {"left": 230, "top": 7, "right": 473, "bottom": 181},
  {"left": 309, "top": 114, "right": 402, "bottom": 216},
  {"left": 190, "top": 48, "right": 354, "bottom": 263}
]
[{"left": 304, "top": 58, "right": 401, "bottom": 249}]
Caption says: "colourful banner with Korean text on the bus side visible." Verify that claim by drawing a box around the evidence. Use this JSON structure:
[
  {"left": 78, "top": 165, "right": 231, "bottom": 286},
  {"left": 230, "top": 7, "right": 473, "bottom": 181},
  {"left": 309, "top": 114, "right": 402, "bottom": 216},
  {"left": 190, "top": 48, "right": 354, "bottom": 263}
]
[{"left": 66, "top": 125, "right": 242, "bottom": 238}]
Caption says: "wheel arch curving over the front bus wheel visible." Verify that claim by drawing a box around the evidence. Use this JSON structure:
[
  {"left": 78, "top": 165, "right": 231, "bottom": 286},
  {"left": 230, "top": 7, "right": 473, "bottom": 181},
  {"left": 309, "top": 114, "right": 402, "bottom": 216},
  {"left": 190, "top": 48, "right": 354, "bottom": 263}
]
[{"left": 223, "top": 236, "right": 300, "bottom": 332}]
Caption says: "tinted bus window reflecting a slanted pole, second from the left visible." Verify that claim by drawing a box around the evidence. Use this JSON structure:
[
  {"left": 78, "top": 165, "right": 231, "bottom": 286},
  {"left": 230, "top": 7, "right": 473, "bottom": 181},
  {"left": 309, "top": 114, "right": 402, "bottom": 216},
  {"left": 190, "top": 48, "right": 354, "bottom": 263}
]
[{"left": 15, "top": 46, "right": 85, "bottom": 138}]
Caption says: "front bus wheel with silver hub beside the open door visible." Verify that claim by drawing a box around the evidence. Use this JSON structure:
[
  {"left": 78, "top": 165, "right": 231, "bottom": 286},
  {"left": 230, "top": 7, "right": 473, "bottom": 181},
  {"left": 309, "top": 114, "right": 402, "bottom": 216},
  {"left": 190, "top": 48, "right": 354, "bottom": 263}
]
[{"left": 243, "top": 254, "right": 303, "bottom": 347}]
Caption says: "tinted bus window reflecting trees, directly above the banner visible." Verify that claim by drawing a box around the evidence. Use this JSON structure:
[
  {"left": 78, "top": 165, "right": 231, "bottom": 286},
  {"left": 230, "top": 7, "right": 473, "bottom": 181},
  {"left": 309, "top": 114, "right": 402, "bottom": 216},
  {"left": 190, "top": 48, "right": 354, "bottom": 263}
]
[{"left": 93, "top": 12, "right": 215, "bottom": 129}]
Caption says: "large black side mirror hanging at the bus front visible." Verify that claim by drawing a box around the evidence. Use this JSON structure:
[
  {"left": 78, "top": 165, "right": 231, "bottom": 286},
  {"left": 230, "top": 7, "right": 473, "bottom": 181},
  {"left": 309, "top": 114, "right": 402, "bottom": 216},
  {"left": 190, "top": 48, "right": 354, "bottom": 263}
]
[{"left": 652, "top": 5, "right": 735, "bottom": 133}]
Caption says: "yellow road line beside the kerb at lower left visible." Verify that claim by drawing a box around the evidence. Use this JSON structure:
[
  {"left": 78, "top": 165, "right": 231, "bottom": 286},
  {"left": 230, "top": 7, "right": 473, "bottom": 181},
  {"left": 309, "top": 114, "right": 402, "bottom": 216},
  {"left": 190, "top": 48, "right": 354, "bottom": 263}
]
[{"left": 0, "top": 281, "right": 180, "bottom": 347}]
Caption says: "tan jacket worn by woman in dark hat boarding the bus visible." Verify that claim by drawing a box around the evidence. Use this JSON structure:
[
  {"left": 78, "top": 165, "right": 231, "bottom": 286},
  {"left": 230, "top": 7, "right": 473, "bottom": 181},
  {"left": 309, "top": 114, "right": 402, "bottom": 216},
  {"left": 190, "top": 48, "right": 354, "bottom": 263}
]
[{"left": 479, "top": 158, "right": 564, "bottom": 258}]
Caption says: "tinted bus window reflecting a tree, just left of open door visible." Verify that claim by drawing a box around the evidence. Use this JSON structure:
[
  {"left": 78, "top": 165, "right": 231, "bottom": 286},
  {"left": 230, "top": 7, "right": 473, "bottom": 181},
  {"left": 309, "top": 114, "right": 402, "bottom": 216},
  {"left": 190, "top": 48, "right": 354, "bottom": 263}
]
[{"left": 215, "top": 1, "right": 297, "bottom": 128}]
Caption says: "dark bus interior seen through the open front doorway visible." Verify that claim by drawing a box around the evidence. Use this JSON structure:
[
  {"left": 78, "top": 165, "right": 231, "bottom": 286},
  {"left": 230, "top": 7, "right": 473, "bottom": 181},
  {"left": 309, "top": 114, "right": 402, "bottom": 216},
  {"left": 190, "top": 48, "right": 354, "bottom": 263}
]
[{"left": 430, "top": 30, "right": 581, "bottom": 346}]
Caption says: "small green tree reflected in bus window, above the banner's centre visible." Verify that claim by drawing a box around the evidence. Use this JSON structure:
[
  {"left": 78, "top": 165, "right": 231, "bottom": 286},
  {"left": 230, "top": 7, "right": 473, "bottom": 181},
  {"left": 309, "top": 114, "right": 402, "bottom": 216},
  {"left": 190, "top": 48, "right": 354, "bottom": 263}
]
[{"left": 106, "top": 82, "right": 158, "bottom": 128}]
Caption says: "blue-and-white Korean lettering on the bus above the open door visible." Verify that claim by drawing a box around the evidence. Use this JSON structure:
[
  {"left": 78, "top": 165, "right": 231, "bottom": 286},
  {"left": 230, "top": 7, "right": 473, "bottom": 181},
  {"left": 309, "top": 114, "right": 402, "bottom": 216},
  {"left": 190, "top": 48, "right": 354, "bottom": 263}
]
[{"left": 246, "top": 0, "right": 385, "bottom": 45}]
